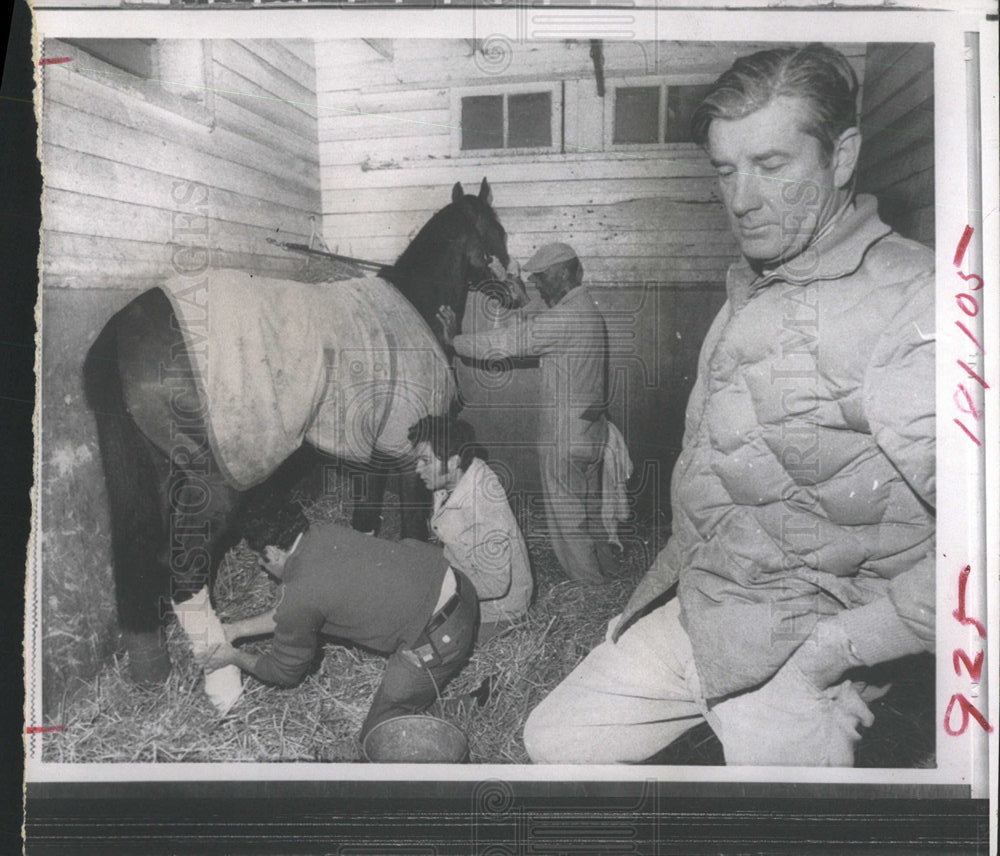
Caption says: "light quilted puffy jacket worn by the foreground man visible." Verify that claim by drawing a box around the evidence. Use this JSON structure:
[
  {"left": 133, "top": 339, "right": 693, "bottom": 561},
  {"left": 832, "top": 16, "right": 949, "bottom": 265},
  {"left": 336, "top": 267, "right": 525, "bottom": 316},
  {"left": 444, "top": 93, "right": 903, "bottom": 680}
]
[{"left": 621, "top": 196, "right": 935, "bottom": 699}]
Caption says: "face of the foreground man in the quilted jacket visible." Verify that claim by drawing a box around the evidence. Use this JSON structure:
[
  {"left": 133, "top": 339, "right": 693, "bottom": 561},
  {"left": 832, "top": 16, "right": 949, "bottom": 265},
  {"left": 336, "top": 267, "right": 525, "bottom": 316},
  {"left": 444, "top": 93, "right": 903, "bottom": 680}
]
[{"left": 708, "top": 96, "right": 859, "bottom": 267}]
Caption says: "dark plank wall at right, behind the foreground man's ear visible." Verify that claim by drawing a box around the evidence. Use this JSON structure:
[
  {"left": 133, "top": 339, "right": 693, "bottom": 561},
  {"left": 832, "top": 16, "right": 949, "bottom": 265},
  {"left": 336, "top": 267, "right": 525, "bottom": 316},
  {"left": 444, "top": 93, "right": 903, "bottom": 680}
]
[{"left": 858, "top": 44, "right": 934, "bottom": 247}]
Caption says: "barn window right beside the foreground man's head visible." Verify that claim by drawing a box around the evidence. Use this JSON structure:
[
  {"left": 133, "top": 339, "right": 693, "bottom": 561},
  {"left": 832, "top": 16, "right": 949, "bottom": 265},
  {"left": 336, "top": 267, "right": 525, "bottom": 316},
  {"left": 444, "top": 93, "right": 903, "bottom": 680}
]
[{"left": 605, "top": 78, "right": 711, "bottom": 148}]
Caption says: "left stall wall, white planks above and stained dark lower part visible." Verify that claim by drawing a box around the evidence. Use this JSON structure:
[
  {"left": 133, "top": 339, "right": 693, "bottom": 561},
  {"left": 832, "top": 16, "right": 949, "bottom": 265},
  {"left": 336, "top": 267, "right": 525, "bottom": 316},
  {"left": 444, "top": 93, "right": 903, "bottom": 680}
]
[{"left": 39, "top": 40, "right": 320, "bottom": 713}]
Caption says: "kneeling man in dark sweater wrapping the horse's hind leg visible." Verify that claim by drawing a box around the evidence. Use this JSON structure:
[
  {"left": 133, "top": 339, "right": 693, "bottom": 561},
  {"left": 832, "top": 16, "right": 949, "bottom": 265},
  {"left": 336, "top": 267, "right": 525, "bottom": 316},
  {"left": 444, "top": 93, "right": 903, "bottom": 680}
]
[{"left": 203, "top": 522, "right": 479, "bottom": 740}]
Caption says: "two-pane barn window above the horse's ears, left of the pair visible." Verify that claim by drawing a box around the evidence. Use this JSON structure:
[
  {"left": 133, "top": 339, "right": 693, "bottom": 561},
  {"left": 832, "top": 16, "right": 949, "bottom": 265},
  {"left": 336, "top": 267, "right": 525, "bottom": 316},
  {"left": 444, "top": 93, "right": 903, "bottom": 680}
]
[{"left": 453, "top": 84, "right": 561, "bottom": 154}]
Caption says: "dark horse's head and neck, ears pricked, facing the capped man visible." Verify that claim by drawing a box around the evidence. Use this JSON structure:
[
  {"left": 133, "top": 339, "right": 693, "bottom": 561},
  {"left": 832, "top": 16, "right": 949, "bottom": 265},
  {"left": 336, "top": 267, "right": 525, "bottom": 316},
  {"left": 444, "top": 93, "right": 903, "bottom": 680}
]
[{"left": 382, "top": 178, "right": 510, "bottom": 346}]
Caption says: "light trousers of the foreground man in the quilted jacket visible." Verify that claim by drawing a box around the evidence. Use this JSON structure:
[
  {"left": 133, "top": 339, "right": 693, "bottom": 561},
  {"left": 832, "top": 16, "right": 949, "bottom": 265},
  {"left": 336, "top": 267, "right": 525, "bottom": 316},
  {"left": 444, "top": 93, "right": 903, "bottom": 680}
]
[{"left": 524, "top": 598, "right": 872, "bottom": 766}]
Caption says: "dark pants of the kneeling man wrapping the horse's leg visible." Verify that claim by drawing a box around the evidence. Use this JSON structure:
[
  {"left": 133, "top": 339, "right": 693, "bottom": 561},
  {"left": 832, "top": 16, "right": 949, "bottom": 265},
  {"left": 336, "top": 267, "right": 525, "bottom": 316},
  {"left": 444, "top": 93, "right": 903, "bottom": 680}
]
[{"left": 361, "top": 571, "right": 479, "bottom": 740}]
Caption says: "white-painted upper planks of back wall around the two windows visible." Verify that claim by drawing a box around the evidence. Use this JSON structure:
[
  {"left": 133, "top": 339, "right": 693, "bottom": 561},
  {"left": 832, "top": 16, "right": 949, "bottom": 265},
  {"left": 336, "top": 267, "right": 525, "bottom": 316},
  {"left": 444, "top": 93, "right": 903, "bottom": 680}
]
[{"left": 316, "top": 39, "right": 864, "bottom": 286}]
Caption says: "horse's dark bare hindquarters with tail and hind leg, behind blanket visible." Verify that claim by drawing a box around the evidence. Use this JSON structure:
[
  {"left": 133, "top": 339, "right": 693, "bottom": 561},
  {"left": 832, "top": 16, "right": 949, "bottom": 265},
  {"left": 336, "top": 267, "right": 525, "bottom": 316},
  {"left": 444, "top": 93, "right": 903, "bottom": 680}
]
[{"left": 92, "top": 289, "right": 244, "bottom": 682}]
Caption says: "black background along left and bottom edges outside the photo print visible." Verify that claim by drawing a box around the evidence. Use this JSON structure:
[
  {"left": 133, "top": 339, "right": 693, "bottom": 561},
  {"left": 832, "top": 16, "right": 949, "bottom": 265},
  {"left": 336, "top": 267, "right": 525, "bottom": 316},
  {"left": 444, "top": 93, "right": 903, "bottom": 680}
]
[{"left": 0, "top": 0, "right": 989, "bottom": 856}]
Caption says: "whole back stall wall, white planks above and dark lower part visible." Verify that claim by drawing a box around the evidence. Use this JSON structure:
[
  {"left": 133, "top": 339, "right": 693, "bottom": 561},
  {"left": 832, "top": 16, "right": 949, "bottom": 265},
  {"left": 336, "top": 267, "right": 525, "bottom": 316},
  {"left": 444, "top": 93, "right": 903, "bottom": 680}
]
[{"left": 316, "top": 39, "right": 865, "bottom": 516}]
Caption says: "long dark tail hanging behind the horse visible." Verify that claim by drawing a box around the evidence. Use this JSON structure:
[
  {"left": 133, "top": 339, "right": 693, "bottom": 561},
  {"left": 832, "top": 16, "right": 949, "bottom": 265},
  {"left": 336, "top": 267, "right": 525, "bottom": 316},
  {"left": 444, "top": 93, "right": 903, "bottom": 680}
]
[{"left": 83, "top": 304, "right": 170, "bottom": 644}]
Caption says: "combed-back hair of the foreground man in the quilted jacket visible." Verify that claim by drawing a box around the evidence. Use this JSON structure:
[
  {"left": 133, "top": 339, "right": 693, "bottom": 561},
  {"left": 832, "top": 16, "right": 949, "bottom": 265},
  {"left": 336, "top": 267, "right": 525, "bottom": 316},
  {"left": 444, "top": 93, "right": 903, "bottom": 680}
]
[{"left": 691, "top": 44, "right": 858, "bottom": 160}]
